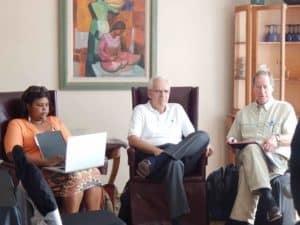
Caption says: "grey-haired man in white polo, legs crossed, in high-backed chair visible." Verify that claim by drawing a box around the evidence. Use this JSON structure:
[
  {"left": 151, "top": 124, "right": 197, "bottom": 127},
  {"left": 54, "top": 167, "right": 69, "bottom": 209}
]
[{"left": 128, "top": 77, "right": 213, "bottom": 225}]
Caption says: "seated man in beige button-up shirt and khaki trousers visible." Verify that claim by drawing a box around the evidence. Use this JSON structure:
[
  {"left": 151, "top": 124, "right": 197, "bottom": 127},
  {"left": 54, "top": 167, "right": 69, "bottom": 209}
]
[{"left": 226, "top": 68, "right": 297, "bottom": 225}]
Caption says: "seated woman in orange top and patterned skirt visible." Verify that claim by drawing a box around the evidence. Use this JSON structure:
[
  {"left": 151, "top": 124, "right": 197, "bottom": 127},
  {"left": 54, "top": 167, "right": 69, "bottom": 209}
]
[{"left": 4, "top": 86, "right": 103, "bottom": 213}]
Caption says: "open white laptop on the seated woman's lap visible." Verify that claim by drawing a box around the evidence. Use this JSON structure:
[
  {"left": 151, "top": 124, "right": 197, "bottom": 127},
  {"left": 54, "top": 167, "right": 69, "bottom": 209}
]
[{"left": 40, "top": 132, "right": 107, "bottom": 173}]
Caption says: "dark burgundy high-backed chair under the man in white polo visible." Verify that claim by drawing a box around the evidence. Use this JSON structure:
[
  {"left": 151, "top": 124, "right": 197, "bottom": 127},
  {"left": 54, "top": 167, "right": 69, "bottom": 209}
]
[{"left": 127, "top": 87, "right": 208, "bottom": 225}]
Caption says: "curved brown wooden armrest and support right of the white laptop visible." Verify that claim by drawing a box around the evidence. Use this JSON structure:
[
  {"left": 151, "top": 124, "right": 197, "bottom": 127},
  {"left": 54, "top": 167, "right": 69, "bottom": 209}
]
[{"left": 106, "top": 138, "right": 128, "bottom": 184}]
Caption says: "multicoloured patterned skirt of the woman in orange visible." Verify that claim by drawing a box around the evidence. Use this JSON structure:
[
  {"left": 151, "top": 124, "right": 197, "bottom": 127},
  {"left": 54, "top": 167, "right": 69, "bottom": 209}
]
[{"left": 43, "top": 168, "right": 101, "bottom": 197}]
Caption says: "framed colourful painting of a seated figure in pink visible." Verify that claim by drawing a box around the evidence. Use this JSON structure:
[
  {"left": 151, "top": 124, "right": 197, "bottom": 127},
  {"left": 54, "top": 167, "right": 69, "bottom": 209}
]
[{"left": 59, "top": 0, "right": 157, "bottom": 90}]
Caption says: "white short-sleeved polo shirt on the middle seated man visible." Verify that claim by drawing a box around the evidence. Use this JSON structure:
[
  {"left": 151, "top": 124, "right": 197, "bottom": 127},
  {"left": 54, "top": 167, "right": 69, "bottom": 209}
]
[{"left": 128, "top": 102, "right": 195, "bottom": 146}]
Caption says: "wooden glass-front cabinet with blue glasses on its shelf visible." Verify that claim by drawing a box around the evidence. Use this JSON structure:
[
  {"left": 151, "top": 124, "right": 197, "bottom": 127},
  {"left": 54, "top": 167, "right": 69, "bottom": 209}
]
[{"left": 227, "top": 4, "right": 300, "bottom": 162}]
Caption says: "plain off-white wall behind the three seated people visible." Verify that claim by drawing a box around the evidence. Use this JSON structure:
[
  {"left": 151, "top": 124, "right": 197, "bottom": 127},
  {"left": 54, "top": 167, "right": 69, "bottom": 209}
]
[{"left": 0, "top": 0, "right": 241, "bottom": 190}]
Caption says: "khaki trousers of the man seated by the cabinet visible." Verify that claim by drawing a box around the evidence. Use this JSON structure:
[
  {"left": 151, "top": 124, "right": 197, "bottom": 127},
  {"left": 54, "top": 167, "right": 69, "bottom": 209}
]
[{"left": 230, "top": 144, "right": 287, "bottom": 224}]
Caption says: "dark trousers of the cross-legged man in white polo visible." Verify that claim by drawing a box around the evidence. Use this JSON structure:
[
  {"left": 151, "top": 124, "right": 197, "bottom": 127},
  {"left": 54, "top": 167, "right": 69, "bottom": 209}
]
[{"left": 136, "top": 131, "right": 209, "bottom": 219}]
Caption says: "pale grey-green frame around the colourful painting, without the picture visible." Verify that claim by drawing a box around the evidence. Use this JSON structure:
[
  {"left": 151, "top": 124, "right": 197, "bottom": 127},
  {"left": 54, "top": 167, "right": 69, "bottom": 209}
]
[{"left": 59, "top": 0, "right": 157, "bottom": 90}]
